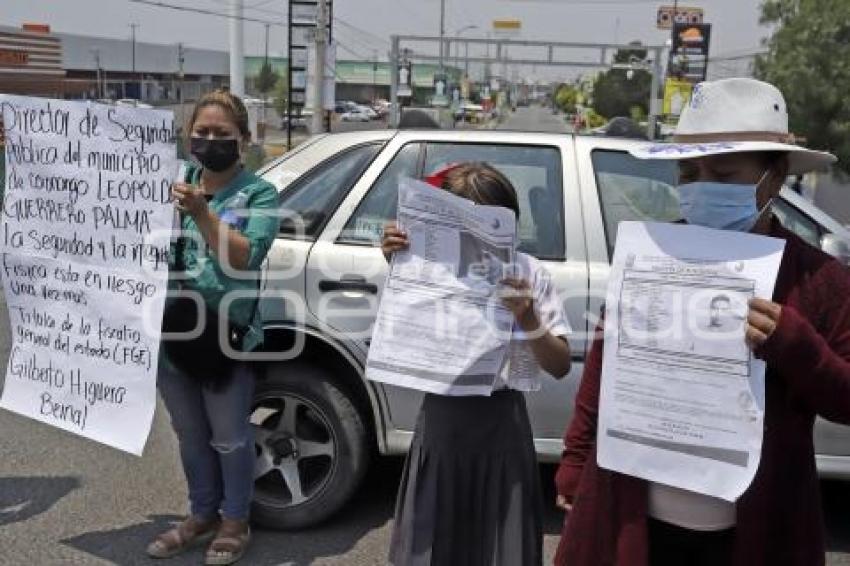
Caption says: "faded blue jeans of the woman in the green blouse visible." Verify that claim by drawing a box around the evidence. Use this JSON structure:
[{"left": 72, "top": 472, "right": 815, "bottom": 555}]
[{"left": 157, "top": 360, "right": 256, "bottom": 521}]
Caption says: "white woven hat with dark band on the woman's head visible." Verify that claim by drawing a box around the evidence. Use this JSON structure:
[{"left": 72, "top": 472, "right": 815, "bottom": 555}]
[{"left": 631, "top": 78, "right": 837, "bottom": 175}]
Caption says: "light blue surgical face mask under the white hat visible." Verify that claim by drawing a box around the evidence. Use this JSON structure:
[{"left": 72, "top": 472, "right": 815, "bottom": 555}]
[{"left": 679, "top": 171, "right": 770, "bottom": 232}]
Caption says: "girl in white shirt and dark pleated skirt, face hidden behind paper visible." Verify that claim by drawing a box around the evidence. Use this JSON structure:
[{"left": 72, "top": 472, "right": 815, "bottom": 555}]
[{"left": 382, "top": 163, "right": 570, "bottom": 566}]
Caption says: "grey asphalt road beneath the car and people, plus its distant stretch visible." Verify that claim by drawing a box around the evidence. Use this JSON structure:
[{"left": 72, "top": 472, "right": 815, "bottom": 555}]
[{"left": 0, "top": 108, "right": 850, "bottom": 566}]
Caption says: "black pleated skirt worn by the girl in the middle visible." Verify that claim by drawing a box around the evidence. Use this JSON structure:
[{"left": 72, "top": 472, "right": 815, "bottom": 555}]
[{"left": 389, "top": 391, "right": 543, "bottom": 566}]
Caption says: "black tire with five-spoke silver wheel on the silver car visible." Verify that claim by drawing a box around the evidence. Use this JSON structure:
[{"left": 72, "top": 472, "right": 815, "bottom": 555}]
[{"left": 251, "top": 362, "right": 369, "bottom": 529}]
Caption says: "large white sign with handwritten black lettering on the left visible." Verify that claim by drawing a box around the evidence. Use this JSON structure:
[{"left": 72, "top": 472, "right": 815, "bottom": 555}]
[{"left": 0, "top": 95, "right": 177, "bottom": 455}]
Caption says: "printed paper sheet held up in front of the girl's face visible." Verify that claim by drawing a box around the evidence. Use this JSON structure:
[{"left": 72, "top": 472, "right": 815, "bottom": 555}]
[{"left": 366, "top": 179, "right": 516, "bottom": 395}]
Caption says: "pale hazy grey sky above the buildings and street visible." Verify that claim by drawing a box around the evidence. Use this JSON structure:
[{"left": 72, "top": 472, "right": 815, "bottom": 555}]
[{"left": 0, "top": 0, "right": 768, "bottom": 76}]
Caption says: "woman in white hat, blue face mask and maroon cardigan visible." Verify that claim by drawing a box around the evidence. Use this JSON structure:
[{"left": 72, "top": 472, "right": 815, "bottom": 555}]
[{"left": 555, "top": 79, "right": 850, "bottom": 566}]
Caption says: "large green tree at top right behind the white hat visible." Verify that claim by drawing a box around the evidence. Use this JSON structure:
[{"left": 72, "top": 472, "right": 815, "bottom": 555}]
[{"left": 755, "top": 0, "right": 850, "bottom": 172}]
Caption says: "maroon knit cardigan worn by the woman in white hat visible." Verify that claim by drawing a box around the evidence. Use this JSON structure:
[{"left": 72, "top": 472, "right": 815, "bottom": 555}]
[{"left": 555, "top": 224, "right": 850, "bottom": 566}]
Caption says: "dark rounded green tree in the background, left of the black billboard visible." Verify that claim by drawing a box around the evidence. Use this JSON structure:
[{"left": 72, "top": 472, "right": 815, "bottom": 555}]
[{"left": 593, "top": 42, "right": 652, "bottom": 118}]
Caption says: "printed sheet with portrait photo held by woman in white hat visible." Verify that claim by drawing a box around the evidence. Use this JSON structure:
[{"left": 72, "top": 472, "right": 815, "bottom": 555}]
[{"left": 597, "top": 222, "right": 785, "bottom": 501}]
